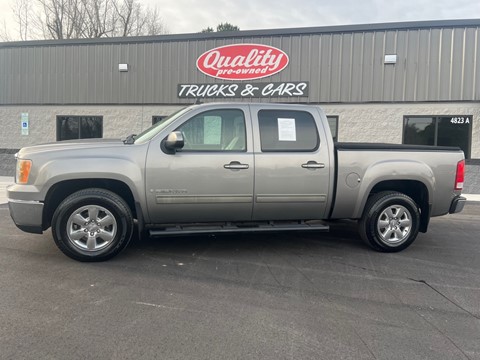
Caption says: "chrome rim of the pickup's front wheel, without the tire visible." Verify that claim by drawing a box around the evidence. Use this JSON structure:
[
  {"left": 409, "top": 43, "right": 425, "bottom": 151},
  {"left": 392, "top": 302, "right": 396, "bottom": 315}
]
[{"left": 67, "top": 205, "right": 117, "bottom": 252}]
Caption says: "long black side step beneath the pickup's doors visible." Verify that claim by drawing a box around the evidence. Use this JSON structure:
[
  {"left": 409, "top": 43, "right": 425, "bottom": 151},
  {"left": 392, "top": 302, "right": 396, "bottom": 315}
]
[{"left": 149, "top": 221, "right": 329, "bottom": 236}]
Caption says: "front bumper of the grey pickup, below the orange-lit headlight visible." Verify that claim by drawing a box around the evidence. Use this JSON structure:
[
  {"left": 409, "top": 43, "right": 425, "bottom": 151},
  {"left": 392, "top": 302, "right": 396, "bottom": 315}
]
[{"left": 8, "top": 199, "right": 43, "bottom": 234}]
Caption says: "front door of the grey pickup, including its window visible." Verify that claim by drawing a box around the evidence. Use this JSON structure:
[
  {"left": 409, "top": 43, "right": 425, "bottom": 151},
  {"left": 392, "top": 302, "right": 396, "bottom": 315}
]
[{"left": 146, "top": 104, "right": 254, "bottom": 224}]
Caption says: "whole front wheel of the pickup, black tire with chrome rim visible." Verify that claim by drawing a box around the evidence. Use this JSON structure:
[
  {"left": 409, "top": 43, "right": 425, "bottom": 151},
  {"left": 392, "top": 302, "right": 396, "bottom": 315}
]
[{"left": 52, "top": 188, "right": 133, "bottom": 262}]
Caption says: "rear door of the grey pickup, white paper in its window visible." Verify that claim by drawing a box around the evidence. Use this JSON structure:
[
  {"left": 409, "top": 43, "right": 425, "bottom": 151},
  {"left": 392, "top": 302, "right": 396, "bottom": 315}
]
[{"left": 251, "top": 106, "right": 333, "bottom": 220}]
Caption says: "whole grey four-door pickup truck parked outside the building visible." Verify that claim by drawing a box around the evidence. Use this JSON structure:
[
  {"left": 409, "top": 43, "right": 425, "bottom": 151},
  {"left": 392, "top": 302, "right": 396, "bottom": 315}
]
[{"left": 7, "top": 103, "right": 466, "bottom": 261}]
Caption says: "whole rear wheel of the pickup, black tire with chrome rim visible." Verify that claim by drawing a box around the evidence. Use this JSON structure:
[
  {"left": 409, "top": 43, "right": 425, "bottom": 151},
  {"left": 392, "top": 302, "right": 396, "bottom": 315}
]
[{"left": 359, "top": 191, "right": 420, "bottom": 252}]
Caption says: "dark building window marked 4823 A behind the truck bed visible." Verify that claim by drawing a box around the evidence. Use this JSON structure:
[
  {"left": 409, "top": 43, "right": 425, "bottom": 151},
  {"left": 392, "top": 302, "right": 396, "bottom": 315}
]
[{"left": 403, "top": 115, "right": 473, "bottom": 159}]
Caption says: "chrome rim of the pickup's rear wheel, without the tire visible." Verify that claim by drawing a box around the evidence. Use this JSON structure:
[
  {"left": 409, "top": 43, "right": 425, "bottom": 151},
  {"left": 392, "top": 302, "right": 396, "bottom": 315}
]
[{"left": 377, "top": 205, "right": 412, "bottom": 245}]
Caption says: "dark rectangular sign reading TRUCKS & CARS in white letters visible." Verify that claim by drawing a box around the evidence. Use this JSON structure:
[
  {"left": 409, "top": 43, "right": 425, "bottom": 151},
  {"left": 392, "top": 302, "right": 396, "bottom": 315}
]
[{"left": 177, "top": 81, "right": 308, "bottom": 99}]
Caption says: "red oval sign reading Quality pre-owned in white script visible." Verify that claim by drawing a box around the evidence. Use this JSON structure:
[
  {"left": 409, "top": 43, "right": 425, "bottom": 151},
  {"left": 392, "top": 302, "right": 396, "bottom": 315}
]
[{"left": 197, "top": 44, "right": 289, "bottom": 80}]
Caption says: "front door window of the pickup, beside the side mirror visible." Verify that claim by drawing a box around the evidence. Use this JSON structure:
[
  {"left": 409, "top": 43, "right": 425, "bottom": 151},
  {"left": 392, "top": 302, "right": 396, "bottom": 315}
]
[{"left": 177, "top": 109, "right": 247, "bottom": 151}]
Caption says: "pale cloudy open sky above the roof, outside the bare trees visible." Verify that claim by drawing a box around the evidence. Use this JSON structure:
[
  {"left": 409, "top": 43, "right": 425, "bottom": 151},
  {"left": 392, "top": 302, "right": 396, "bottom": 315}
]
[{"left": 0, "top": 0, "right": 480, "bottom": 38}]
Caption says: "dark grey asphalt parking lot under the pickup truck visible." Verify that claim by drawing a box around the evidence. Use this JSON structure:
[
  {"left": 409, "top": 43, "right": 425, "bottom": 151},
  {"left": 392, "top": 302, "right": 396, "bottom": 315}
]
[{"left": 0, "top": 202, "right": 480, "bottom": 359}]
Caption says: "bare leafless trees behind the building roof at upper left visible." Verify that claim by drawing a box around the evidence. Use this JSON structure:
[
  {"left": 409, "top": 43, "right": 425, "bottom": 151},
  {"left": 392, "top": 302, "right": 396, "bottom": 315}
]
[{"left": 0, "top": 0, "right": 168, "bottom": 40}]
